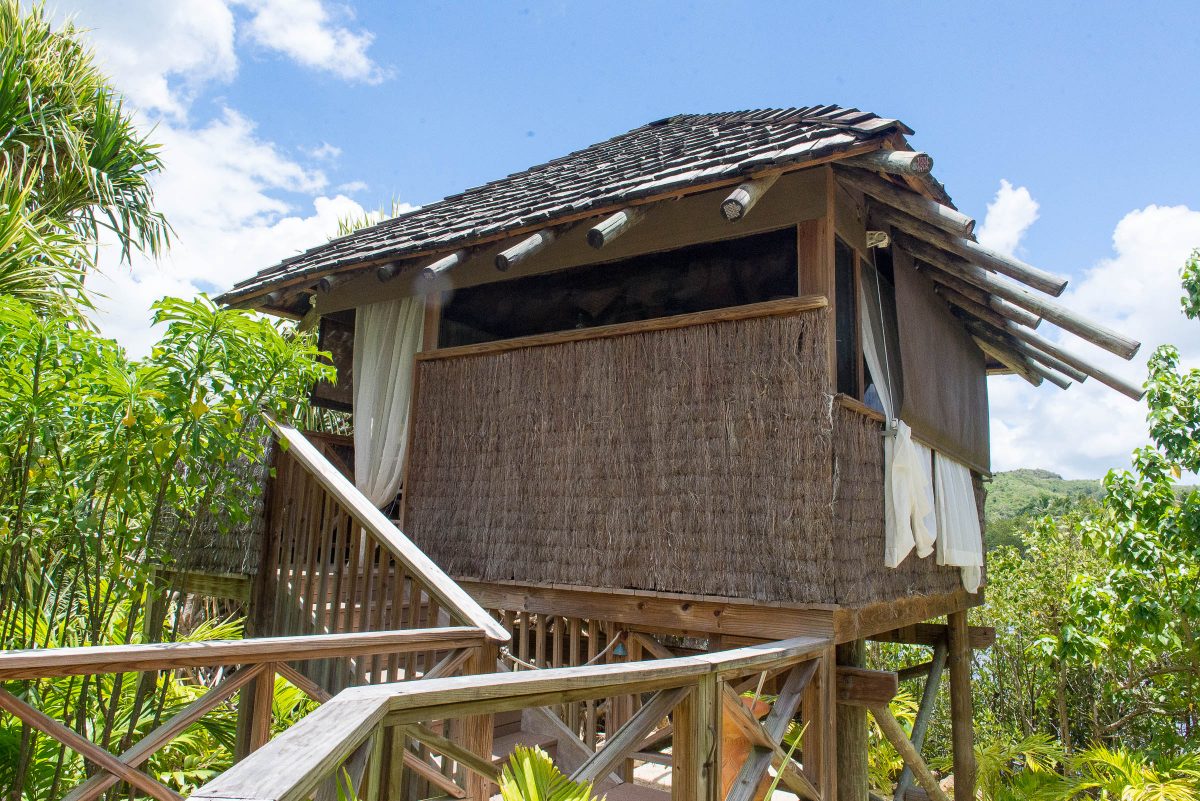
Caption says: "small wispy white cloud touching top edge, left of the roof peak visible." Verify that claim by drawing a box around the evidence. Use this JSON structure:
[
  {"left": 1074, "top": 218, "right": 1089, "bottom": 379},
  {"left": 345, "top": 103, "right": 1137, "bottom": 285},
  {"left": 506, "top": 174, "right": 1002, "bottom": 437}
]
[{"left": 236, "top": 0, "right": 389, "bottom": 84}]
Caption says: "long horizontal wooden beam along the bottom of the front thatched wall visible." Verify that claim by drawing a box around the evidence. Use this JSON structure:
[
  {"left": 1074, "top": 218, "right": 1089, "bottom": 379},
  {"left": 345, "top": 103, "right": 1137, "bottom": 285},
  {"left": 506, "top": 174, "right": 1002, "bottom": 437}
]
[{"left": 458, "top": 578, "right": 835, "bottom": 642}]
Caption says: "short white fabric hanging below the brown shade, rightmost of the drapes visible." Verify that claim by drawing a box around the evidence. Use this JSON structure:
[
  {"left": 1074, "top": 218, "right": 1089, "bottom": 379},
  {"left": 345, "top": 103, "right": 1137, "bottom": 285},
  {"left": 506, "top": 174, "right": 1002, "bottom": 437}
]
[{"left": 934, "top": 453, "right": 983, "bottom": 592}]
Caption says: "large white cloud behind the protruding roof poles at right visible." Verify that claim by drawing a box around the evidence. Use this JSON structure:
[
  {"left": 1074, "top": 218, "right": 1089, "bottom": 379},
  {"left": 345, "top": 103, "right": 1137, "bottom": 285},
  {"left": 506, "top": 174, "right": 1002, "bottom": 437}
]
[{"left": 989, "top": 205, "right": 1200, "bottom": 477}]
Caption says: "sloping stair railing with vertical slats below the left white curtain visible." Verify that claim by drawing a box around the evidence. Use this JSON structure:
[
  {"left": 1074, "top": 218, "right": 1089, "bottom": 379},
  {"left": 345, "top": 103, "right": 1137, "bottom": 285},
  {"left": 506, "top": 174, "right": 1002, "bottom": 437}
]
[{"left": 254, "top": 421, "right": 509, "bottom": 693}]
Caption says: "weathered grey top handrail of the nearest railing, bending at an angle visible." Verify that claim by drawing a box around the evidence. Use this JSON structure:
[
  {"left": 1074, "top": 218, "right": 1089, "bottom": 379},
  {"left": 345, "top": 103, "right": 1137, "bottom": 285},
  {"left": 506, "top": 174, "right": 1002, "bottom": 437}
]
[{"left": 199, "top": 637, "right": 833, "bottom": 801}]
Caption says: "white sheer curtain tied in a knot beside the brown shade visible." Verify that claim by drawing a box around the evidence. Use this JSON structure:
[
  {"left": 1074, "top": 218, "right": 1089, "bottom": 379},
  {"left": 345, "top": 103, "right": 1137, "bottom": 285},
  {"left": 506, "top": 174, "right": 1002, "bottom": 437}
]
[{"left": 858, "top": 263, "right": 937, "bottom": 567}]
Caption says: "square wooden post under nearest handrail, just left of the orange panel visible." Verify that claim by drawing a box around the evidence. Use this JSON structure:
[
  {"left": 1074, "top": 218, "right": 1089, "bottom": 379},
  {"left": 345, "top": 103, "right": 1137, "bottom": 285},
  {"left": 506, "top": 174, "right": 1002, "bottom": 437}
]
[{"left": 671, "top": 674, "right": 721, "bottom": 801}]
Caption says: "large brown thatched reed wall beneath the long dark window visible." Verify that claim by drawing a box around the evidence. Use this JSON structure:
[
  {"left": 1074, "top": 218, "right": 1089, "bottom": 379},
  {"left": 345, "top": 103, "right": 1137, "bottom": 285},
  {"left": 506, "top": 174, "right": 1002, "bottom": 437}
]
[{"left": 404, "top": 309, "right": 979, "bottom": 603}]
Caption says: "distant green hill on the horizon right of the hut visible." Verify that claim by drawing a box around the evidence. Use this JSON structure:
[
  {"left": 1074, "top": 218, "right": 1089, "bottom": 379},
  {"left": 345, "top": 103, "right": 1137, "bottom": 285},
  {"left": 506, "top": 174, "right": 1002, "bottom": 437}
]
[{"left": 984, "top": 469, "right": 1104, "bottom": 548}]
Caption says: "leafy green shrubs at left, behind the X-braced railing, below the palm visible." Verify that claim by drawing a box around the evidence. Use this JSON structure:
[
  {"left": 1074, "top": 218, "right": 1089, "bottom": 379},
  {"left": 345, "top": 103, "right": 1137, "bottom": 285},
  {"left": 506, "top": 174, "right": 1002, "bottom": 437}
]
[{"left": 0, "top": 296, "right": 332, "bottom": 800}]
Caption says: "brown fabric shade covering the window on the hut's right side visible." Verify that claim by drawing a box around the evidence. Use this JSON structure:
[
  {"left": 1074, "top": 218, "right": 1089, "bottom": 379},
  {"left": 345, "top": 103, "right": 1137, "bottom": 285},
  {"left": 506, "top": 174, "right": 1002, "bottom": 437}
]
[{"left": 893, "top": 249, "right": 991, "bottom": 472}]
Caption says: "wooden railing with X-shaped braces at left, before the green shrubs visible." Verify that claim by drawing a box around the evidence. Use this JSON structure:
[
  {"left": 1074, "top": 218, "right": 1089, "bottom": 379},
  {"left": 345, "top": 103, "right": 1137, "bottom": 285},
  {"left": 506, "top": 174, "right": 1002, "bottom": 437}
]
[{"left": 0, "top": 626, "right": 491, "bottom": 801}]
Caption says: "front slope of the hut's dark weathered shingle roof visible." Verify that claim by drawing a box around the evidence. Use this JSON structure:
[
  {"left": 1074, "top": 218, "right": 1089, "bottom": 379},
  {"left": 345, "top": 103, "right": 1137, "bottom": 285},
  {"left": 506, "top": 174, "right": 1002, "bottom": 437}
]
[{"left": 221, "top": 106, "right": 912, "bottom": 302}]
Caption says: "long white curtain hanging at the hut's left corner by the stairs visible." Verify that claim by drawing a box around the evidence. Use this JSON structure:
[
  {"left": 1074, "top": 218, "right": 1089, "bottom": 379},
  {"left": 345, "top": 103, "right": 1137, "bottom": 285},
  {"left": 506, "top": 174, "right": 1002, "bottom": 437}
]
[{"left": 354, "top": 296, "right": 425, "bottom": 507}]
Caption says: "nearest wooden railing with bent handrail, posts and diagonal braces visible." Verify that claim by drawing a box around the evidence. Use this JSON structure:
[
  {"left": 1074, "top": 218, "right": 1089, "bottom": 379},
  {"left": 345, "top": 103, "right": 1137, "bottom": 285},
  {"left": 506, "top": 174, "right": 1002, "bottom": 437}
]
[{"left": 192, "top": 637, "right": 836, "bottom": 801}]
